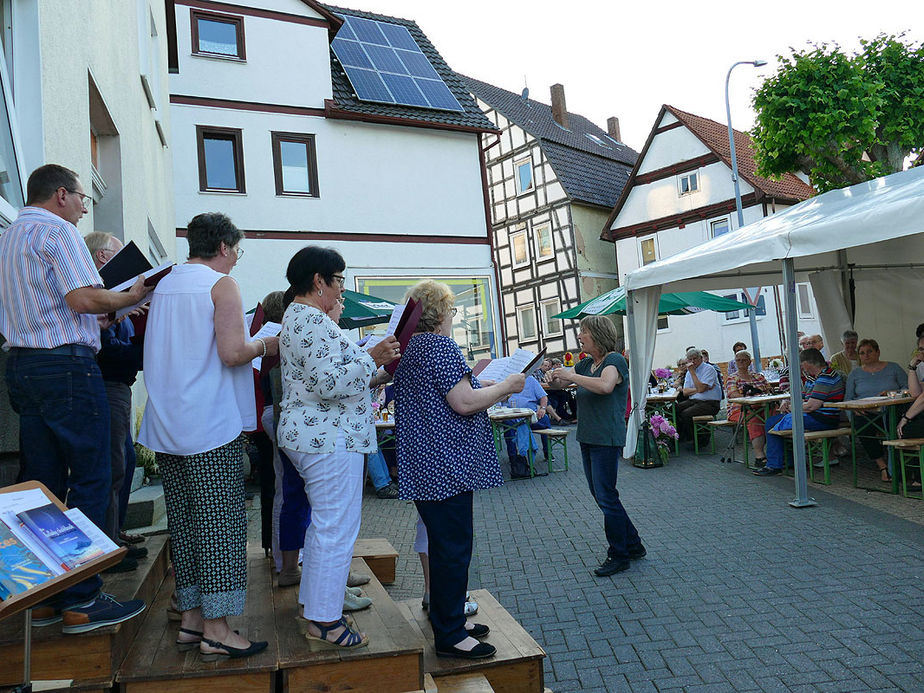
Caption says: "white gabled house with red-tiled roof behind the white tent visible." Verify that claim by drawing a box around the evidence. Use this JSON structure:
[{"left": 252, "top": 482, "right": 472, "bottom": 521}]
[{"left": 602, "top": 106, "right": 824, "bottom": 367}]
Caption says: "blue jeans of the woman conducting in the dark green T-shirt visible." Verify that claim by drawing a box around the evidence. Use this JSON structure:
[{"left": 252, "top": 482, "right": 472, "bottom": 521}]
[{"left": 581, "top": 443, "right": 642, "bottom": 560}]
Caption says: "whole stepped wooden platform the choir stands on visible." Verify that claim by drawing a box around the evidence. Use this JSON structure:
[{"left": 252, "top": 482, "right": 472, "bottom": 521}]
[{"left": 0, "top": 537, "right": 545, "bottom": 693}]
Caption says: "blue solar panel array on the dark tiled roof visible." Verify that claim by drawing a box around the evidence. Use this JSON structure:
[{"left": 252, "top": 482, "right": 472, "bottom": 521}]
[{"left": 331, "top": 16, "right": 465, "bottom": 111}]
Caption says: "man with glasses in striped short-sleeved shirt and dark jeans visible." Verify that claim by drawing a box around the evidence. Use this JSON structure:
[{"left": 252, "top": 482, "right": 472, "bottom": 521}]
[{"left": 0, "top": 164, "right": 150, "bottom": 633}]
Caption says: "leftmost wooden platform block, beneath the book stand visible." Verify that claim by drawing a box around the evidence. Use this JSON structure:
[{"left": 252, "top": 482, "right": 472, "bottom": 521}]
[{"left": 0, "top": 536, "right": 168, "bottom": 689}]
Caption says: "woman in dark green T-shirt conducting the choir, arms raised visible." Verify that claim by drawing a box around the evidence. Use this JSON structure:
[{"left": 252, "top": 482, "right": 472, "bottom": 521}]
[{"left": 552, "top": 315, "right": 647, "bottom": 577}]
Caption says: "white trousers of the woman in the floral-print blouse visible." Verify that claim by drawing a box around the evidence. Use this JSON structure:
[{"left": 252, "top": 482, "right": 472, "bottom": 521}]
[{"left": 284, "top": 435, "right": 363, "bottom": 622}]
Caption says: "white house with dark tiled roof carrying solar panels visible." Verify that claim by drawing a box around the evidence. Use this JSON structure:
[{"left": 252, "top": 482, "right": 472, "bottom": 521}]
[{"left": 170, "top": 0, "right": 500, "bottom": 360}]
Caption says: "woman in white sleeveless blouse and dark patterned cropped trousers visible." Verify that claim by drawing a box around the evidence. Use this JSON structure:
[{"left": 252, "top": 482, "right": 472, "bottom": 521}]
[{"left": 138, "top": 213, "right": 278, "bottom": 660}]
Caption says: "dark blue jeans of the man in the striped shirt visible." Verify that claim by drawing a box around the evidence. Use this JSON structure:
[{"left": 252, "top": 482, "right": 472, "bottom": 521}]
[{"left": 6, "top": 349, "right": 111, "bottom": 606}]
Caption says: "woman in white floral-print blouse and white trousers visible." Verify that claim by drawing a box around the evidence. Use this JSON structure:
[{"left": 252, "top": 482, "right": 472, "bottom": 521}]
[{"left": 276, "top": 246, "right": 400, "bottom": 647}]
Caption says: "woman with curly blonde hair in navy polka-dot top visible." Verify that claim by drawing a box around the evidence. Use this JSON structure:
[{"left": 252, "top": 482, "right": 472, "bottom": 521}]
[{"left": 395, "top": 279, "right": 526, "bottom": 659}]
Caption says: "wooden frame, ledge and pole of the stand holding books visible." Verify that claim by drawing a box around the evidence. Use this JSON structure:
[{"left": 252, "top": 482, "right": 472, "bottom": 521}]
[{"left": 0, "top": 481, "right": 127, "bottom": 693}]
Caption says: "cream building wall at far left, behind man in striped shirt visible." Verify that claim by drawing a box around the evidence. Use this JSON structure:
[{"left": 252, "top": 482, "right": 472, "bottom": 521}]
[{"left": 0, "top": 0, "right": 176, "bottom": 464}]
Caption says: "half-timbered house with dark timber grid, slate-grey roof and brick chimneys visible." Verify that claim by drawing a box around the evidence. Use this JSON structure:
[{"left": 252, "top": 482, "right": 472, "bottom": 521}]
[{"left": 465, "top": 78, "right": 638, "bottom": 354}]
